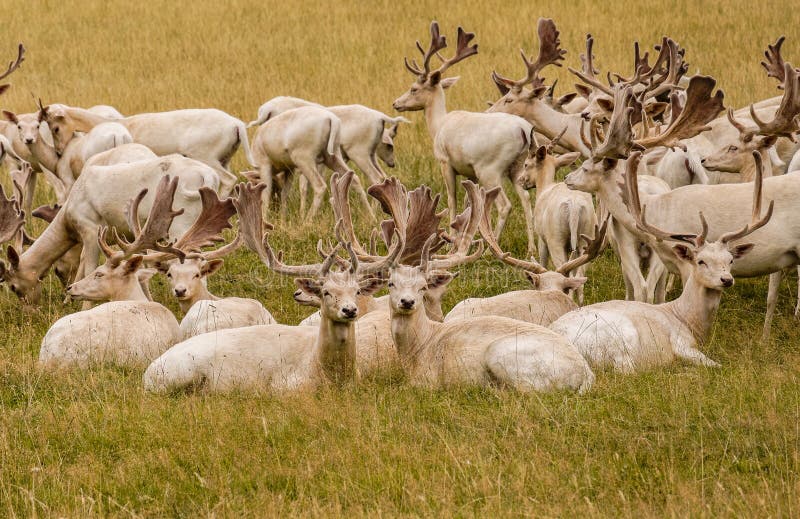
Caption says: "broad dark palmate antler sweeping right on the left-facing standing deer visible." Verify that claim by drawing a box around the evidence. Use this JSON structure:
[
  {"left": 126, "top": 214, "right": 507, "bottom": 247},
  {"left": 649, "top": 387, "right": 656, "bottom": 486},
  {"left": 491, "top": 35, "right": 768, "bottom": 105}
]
[{"left": 635, "top": 76, "right": 725, "bottom": 148}]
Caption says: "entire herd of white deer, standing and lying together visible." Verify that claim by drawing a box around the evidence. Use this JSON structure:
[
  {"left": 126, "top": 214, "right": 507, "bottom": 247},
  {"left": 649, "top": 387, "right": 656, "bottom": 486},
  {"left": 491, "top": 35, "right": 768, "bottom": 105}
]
[{"left": 0, "top": 19, "right": 800, "bottom": 392}]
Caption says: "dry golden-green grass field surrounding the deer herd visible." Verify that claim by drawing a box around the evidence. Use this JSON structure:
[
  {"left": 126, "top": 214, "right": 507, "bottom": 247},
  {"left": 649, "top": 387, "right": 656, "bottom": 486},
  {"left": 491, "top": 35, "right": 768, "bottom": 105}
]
[{"left": 0, "top": 0, "right": 800, "bottom": 517}]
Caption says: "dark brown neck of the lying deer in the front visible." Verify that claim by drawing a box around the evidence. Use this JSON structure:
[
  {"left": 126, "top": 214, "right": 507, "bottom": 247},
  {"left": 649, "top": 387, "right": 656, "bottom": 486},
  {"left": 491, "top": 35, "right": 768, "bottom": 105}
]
[{"left": 316, "top": 312, "right": 357, "bottom": 383}]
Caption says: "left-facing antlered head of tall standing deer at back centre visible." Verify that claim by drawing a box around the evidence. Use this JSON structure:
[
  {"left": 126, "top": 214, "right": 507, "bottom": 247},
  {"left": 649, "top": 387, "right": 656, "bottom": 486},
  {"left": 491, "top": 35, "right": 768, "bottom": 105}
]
[{"left": 392, "top": 21, "right": 478, "bottom": 112}]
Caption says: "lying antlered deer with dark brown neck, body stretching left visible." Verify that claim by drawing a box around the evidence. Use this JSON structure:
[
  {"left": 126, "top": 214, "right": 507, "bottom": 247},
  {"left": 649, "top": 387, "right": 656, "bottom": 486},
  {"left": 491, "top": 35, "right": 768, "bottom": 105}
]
[{"left": 144, "top": 184, "right": 402, "bottom": 392}]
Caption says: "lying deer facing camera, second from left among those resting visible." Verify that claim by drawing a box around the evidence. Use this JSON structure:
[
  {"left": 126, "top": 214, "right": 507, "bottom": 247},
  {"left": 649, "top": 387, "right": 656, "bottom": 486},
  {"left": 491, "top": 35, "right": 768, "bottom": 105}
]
[{"left": 157, "top": 186, "right": 276, "bottom": 340}]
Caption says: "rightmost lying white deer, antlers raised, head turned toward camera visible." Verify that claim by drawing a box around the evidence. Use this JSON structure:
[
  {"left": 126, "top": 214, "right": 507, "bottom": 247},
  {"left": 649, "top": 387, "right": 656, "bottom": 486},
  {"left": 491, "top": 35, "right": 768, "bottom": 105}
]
[{"left": 550, "top": 152, "right": 774, "bottom": 373}]
